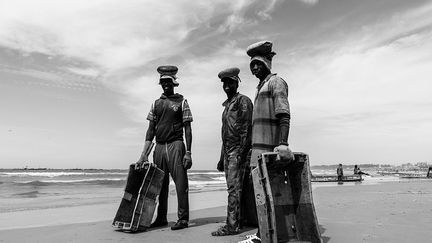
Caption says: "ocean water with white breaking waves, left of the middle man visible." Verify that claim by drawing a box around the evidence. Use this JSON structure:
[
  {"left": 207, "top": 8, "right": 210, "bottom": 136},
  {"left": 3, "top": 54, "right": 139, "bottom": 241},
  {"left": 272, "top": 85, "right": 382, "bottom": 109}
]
[{"left": 0, "top": 169, "right": 226, "bottom": 213}]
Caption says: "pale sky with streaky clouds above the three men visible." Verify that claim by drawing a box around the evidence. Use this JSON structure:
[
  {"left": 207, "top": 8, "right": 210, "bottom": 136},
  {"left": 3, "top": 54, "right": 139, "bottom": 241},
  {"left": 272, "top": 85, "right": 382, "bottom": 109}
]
[{"left": 0, "top": 0, "right": 432, "bottom": 169}]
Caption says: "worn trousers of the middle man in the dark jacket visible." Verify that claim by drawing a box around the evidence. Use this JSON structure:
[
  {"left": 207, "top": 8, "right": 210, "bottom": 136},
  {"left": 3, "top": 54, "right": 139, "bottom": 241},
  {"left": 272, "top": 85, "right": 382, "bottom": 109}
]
[{"left": 224, "top": 152, "right": 245, "bottom": 231}]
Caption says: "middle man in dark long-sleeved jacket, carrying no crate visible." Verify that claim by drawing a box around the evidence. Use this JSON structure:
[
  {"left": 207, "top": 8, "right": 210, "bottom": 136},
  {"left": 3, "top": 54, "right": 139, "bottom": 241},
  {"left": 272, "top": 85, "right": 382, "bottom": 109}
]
[{"left": 212, "top": 68, "right": 253, "bottom": 236}]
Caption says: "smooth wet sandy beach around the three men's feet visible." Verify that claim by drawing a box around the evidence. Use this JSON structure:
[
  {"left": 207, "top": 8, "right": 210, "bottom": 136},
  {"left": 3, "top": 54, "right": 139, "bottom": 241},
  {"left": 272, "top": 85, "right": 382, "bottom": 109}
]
[{"left": 0, "top": 179, "right": 432, "bottom": 243}]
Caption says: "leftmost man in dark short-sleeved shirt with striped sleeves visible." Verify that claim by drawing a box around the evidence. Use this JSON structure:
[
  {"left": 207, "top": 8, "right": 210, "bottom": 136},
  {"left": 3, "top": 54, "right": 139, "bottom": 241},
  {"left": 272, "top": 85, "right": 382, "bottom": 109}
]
[{"left": 137, "top": 66, "right": 193, "bottom": 230}]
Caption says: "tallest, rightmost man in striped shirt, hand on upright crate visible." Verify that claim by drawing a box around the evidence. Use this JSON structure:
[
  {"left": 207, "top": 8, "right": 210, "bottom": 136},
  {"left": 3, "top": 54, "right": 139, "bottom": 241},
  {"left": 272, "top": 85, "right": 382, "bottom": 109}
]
[{"left": 239, "top": 41, "right": 294, "bottom": 243}]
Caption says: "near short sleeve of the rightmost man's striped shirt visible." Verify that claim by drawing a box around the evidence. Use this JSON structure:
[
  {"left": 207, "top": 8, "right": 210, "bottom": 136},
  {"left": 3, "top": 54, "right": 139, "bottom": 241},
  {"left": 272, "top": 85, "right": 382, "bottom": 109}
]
[{"left": 269, "top": 76, "right": 290, "bottom": 115}]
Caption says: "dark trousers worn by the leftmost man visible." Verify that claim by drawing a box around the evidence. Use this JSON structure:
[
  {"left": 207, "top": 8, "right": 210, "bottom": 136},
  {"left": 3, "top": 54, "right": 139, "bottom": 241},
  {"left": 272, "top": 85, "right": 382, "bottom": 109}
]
[{"left": 153, "top": 141, "right": 189, "bottom": 222}]
